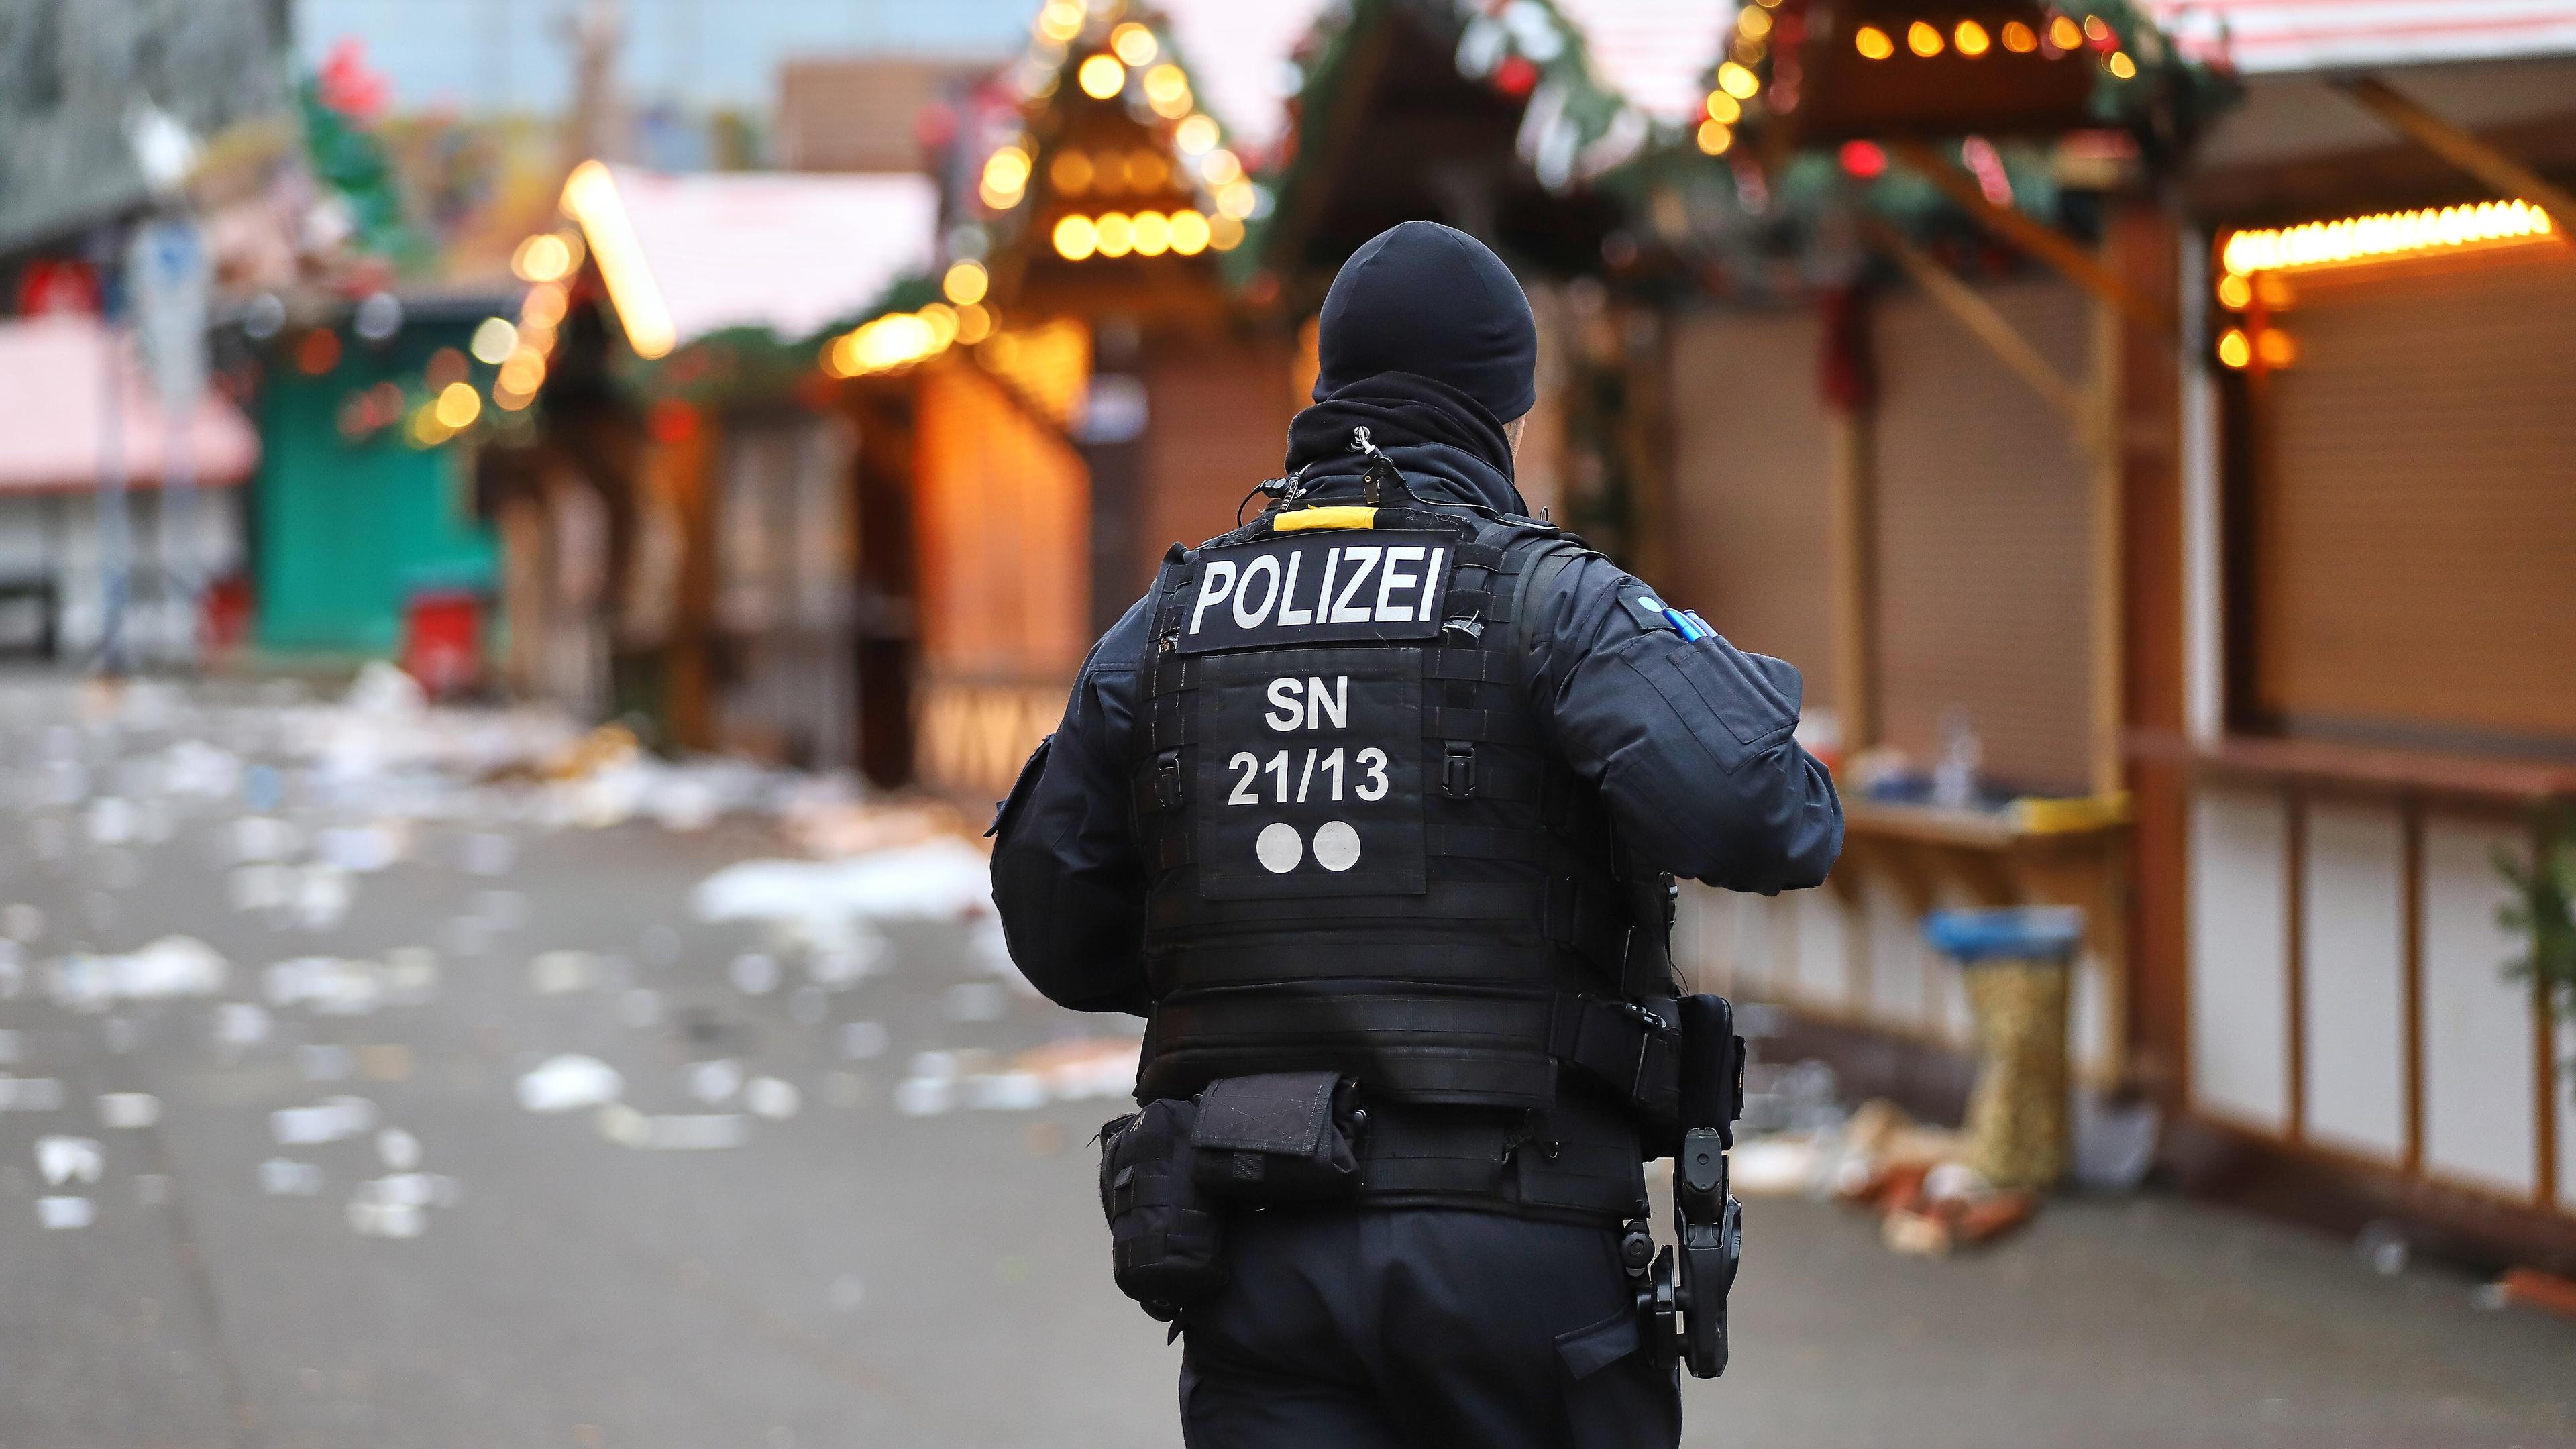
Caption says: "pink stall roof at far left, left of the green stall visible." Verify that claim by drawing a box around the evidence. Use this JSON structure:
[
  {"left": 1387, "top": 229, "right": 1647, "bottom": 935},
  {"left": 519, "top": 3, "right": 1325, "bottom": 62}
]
[{"left": 0, "top": 317, "right": 260, "bottom": 492}]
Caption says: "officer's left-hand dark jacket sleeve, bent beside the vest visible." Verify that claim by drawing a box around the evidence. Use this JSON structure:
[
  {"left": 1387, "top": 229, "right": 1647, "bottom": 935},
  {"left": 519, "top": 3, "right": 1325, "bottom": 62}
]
[{"left": 991, "top": 601, "right": 1151, "bottom": 1013}]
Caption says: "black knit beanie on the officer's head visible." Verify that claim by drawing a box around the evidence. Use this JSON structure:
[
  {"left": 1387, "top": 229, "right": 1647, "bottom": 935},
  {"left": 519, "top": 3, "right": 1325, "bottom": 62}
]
[{"left": 1313, "top": 222, "right": 1538, "bottom": 423}]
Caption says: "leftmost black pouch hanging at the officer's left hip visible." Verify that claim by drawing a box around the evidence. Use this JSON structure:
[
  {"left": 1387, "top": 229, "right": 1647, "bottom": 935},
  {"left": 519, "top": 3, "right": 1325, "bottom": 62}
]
[{"left": 1100, "top": 1098, "right": 1226, "bottom": 1323}]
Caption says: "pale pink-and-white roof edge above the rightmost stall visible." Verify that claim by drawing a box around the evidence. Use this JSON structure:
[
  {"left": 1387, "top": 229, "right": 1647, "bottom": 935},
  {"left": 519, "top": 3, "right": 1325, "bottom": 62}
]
[{"left": 2146, "top": 0, "right": 2576, "bottom": 74}]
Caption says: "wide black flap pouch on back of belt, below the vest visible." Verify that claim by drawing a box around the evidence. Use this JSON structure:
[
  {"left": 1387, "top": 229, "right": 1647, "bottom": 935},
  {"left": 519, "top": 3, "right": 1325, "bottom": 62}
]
[{"left": 1190, "top": 1073, "right": 1368, "bottom": 1204}]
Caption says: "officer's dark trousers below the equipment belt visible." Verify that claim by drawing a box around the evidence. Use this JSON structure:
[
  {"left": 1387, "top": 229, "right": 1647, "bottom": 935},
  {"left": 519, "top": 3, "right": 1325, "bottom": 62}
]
[{"left": 1180, "top": 1210, "right": 1682, "bottom": 1449}]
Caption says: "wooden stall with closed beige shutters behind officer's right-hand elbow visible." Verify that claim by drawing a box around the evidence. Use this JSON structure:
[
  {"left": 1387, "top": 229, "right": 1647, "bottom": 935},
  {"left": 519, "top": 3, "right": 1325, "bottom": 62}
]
[{"left": 1641, "top": 0, "right": 2218, "bottom": 1085}]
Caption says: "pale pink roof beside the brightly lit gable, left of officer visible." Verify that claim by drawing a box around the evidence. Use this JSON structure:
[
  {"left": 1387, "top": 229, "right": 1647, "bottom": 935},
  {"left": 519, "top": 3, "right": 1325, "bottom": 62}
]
[{"left": 597, "top": 165, "right": 938, "bottom": 345}]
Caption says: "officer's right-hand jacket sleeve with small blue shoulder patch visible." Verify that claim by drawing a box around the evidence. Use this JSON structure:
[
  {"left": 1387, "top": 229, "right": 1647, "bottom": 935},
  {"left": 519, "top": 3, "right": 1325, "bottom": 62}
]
[{"left": 1522, "top": 554, "right": 1842, "bottom": 895}]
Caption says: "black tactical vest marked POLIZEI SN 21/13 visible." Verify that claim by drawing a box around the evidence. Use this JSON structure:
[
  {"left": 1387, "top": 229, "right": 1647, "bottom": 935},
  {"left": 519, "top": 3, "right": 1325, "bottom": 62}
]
[{"left": 1134, "top": 494, "right": 1674, "bottom": 1175}]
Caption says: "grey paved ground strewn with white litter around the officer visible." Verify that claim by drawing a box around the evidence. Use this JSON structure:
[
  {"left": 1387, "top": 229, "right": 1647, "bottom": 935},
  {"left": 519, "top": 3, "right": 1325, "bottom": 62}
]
[{"left": 0, "top": 680, "right": 2576, "bottom": 1449}]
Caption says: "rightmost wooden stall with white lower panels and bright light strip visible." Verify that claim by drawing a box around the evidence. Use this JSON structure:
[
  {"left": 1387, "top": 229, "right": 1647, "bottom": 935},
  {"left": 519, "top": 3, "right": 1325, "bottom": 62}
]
[{"left": 2131, "top": 5, "right": 2576, "bottom": 1266}]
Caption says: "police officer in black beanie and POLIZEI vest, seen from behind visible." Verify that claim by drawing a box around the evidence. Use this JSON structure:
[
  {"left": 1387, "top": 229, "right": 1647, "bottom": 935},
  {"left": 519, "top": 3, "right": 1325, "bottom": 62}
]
[{"left": 994, "top": 222, "right": 1842, "bottom": 1449}]
